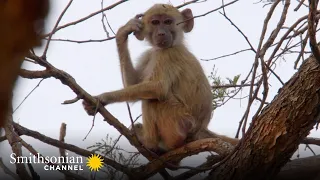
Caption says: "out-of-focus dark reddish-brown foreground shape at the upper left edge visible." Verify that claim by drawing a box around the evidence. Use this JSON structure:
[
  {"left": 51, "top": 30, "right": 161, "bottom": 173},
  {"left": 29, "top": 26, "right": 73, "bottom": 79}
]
[{"left": 0, "top": 0, "right": 50, "bottom": 129}]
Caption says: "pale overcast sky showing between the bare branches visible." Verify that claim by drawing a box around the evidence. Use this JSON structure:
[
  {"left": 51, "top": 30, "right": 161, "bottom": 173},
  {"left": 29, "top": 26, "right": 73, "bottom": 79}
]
[{"left": 0, "top": 0, "right": 320, "bottom": 179}]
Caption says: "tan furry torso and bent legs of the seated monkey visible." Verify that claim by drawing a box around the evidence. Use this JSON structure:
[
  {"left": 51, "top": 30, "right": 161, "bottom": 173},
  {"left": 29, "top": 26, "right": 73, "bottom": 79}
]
[{"left": 137, "top": 45, "right": 212, "bottom": 149}]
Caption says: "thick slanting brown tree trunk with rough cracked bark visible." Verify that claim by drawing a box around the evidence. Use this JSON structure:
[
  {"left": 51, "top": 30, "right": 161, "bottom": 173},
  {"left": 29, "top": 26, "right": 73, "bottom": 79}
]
[{"left": 207, "top": 56, "right": 320, "bottom": 180}]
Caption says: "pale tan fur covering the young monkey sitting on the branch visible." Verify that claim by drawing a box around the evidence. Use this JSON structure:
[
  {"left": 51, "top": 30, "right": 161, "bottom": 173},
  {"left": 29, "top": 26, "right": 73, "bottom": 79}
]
[{"left": 83, "top": 4, "right": 236, "bottom": 155}]
